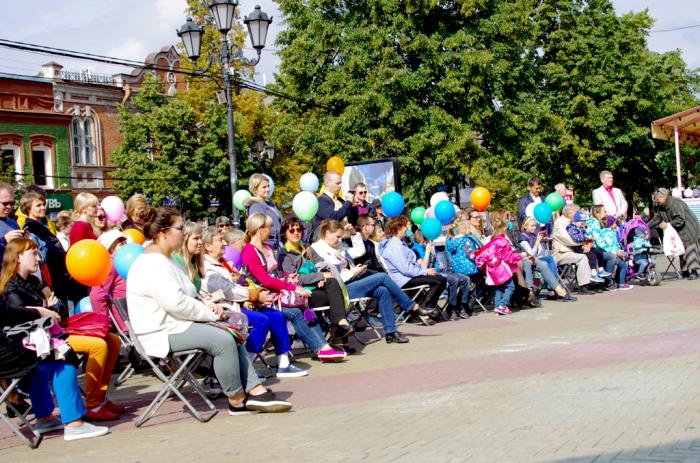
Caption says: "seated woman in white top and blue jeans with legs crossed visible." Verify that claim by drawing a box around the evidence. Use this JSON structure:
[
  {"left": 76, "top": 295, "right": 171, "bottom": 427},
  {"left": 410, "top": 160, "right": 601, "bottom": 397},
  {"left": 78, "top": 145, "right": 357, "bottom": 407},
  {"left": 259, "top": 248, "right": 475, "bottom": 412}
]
[{"left": 311, "top": 220, "right": 435, "bottom": 343}]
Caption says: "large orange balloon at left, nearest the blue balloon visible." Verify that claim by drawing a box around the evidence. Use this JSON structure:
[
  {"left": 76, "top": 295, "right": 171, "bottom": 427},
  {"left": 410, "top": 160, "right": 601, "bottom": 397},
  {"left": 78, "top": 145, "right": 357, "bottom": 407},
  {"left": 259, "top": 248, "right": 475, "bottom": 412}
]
[{"left": 66, "top": 240, "right": 112, "bottom": 286}]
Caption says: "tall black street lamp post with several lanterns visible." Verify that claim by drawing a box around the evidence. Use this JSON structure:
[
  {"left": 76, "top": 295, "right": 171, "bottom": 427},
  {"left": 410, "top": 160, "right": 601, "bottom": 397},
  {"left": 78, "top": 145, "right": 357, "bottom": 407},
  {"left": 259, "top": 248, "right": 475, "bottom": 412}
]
[{"left": 177, "top": 0, "right": 272, "bottom": 226}]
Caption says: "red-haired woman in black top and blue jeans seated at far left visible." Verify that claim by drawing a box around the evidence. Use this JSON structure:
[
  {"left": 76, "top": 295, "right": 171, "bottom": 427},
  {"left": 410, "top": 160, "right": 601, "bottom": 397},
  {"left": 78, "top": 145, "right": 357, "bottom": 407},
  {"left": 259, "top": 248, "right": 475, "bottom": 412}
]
[{"left": 0, "top": 238, "right": 110, "bottom": 440}]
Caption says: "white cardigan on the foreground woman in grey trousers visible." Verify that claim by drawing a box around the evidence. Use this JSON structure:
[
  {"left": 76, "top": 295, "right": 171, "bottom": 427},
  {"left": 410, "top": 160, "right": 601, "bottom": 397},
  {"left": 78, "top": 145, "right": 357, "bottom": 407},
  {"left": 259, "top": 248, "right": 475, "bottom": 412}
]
[{"left": 126, "top": 253, "right": 218, "bottom": 358}]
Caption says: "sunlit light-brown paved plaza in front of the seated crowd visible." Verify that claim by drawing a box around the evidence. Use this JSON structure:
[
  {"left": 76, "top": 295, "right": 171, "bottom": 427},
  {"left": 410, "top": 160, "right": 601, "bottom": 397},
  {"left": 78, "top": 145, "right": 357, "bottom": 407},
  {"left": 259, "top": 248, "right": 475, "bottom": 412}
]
[{"left": 0, "top": 268, "right": 700, "bottom": 463}]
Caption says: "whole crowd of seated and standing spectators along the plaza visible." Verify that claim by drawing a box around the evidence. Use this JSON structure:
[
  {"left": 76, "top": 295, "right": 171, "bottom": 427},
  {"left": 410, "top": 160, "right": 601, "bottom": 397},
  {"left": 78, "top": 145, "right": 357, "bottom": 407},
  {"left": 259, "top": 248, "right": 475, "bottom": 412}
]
[{"left": 0, "top": 171, "right": 700, "bottom": 446}]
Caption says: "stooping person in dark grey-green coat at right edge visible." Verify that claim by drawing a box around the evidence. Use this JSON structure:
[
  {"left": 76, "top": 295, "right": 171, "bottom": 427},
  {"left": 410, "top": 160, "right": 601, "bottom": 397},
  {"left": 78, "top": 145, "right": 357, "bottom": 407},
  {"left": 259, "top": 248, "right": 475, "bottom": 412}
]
[{"left": 649, "top": 188, "right": 700, "bottom": 280}]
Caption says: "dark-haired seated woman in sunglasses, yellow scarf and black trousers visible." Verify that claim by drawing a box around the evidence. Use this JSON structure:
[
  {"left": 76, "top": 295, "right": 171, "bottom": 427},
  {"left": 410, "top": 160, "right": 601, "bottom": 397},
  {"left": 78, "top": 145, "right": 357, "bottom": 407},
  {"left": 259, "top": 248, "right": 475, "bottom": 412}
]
[{"left": 277, "top": 217, "right": 354, "bottom": 339}]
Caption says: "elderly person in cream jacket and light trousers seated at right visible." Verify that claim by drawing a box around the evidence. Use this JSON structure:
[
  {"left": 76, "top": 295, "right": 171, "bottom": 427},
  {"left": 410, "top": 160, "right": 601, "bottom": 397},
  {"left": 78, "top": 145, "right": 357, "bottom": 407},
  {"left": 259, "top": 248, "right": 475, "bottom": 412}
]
[{"left": 552, "top": 204, "right": 593, "bottom": 294}]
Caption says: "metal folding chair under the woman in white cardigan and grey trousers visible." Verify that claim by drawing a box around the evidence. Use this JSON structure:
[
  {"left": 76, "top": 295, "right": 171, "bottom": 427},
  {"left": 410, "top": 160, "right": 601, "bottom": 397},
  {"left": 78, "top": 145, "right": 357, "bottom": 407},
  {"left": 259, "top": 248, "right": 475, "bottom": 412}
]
[{"left": 114, "top": 298, "right": 218, "bottom": 427}]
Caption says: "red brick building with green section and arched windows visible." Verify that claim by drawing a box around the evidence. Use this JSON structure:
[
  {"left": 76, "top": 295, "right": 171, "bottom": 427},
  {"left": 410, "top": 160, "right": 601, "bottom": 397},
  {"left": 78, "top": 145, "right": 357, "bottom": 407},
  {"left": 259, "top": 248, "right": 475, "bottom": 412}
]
[{"left": 0, "top": 46, "right": 185, "bottom": 212}]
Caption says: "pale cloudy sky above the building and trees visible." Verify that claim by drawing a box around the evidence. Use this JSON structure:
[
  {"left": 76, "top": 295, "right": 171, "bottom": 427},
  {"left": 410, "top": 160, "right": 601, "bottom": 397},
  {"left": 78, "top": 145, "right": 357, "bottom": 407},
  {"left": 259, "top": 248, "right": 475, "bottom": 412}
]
[{"left": 0, "top": 0, "right": 700, "bottom": 84}]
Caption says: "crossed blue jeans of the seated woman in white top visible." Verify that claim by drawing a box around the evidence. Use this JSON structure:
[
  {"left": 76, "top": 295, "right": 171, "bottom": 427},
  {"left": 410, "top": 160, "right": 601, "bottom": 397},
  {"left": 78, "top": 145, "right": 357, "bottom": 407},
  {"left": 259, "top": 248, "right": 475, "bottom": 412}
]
[{"left": 346, "top": 273, "right": 414, "bottom": 334}]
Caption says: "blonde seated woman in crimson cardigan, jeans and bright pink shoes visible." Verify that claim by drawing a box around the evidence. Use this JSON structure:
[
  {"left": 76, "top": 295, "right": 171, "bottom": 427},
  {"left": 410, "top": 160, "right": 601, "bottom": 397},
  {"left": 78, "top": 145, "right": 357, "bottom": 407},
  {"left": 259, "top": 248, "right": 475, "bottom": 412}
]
[{"left": 242, "top": 214, "right": 345, "bottom": 362}]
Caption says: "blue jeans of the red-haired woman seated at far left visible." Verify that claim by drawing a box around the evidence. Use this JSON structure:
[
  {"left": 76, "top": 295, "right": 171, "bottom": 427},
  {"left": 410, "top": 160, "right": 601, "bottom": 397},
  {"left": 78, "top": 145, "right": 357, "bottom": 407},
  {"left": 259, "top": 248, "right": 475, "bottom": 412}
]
[{"left": 29, "top": 362, "right": 87, "bottom": 424}]
